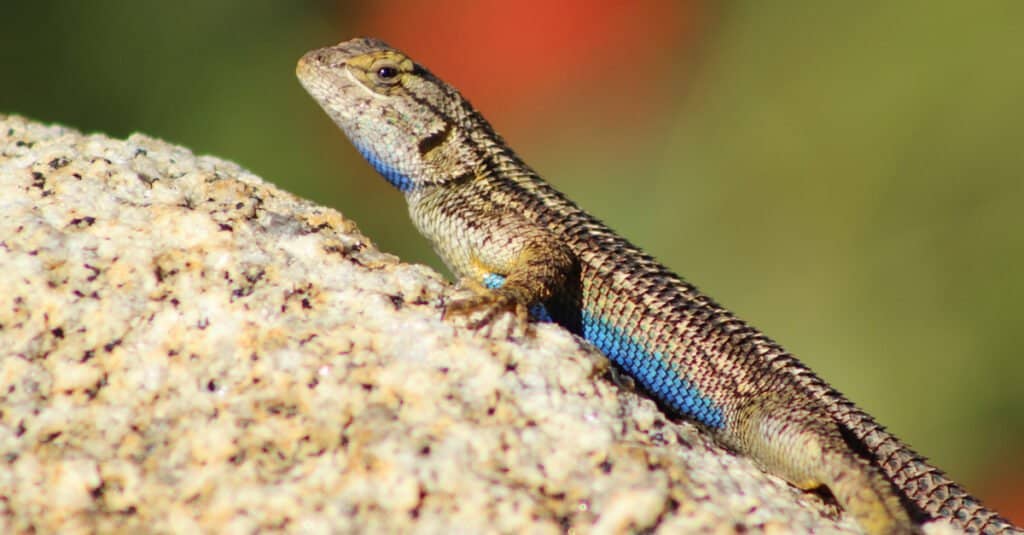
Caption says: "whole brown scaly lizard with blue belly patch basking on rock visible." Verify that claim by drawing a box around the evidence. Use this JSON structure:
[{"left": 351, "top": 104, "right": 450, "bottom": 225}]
[{"left": 296, "top": 38, "right": 1024, "bottom": 534}]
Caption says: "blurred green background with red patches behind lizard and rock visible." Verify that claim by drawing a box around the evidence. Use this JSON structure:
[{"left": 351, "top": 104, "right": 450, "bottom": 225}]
[{"left": 0, "top": 0, "right": 1024, "bottom": 523}]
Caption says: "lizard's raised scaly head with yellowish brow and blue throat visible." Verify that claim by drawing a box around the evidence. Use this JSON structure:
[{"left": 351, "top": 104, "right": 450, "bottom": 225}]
[{"left": 296, "top": 39, "right": 489, "bottom": 193}]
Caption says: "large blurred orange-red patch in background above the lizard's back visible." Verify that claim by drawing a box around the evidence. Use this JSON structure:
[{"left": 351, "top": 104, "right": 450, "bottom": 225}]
[{"left": 354, "top": 0, "right": 701, "bottom": 130}]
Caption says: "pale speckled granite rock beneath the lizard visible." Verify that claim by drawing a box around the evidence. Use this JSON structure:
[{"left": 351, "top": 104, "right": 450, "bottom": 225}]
[{"left": 0, "top": 116, "right": 958, "bottom": 533}]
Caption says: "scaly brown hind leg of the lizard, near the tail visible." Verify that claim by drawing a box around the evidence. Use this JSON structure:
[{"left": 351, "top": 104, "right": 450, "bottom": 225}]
[{"left": 726, "top": 396, "right": 915, "bottom": 535}]
